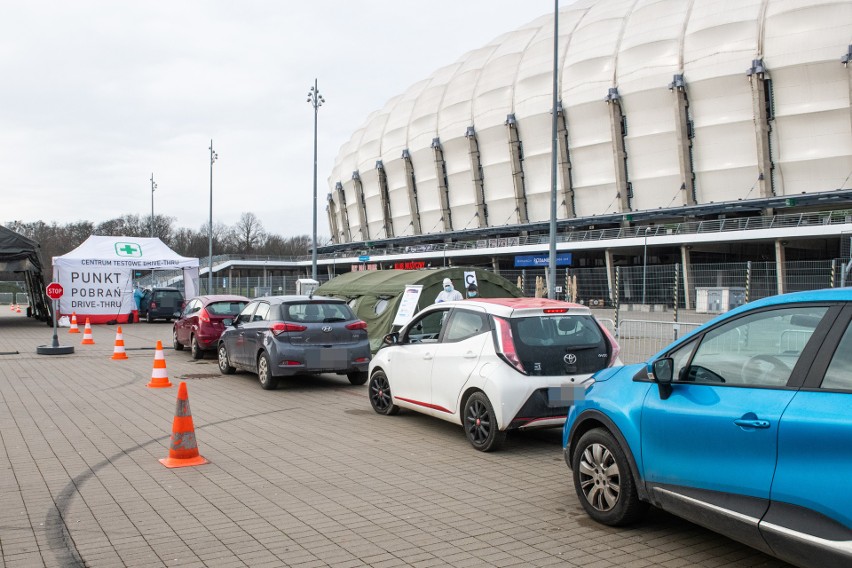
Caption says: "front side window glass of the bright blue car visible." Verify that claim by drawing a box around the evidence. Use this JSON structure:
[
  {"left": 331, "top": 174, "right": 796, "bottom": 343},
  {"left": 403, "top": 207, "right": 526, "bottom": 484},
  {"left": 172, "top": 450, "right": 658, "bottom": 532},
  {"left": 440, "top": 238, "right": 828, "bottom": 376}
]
[{"left": 681, "top": 306, "right": 828, "bottom": 387}]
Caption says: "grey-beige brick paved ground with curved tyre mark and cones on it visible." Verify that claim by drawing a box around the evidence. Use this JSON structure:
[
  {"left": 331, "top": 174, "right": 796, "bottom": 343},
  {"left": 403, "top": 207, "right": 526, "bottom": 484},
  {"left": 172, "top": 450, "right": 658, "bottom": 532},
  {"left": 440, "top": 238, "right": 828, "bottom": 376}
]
[{"left": 0, "top": 313, "right": 784, "bottom": 568}]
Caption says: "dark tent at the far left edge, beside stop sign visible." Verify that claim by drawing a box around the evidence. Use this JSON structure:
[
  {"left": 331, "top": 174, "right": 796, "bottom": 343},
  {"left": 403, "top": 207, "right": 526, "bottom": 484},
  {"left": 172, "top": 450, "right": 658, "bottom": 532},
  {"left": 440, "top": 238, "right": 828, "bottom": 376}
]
[{"left": 0, "top": 226, "right": 51, "bottom": 322}]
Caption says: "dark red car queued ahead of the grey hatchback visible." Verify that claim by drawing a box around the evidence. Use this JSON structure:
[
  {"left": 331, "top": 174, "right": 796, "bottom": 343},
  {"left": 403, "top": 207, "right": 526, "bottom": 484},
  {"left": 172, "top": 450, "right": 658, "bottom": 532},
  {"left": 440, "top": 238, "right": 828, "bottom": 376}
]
[{"left": 172, "top": 295, "right": 250, "bottom": 359}]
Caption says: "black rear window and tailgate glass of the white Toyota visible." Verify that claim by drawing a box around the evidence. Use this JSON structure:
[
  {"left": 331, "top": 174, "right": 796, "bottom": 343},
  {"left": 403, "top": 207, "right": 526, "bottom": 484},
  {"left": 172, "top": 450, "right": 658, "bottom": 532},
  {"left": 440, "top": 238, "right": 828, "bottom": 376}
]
[{"left": 511, "top": 314, "right": 611, "bottom": 375}]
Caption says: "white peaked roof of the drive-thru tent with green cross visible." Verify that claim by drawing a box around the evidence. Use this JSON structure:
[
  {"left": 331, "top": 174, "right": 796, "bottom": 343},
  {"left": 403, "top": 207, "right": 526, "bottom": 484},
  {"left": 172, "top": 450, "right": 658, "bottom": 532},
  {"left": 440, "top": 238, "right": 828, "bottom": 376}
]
[{"left": 53, "top": 235, "right": 198, "bottom": 270}]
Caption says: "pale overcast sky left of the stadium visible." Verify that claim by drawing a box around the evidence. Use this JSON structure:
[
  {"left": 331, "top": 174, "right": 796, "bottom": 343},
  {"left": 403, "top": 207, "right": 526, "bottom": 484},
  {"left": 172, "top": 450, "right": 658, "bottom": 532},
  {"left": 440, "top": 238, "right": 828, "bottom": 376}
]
[{"left": 0, "top": 0, "right": 552, "bottom": 237}]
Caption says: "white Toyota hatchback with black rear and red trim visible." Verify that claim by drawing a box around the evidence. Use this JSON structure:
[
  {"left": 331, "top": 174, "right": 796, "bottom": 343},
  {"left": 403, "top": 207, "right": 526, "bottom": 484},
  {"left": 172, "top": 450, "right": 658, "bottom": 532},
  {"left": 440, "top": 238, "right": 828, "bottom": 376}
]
[{"left": 368, "top": 298, "right": 621, "bottom": 452}]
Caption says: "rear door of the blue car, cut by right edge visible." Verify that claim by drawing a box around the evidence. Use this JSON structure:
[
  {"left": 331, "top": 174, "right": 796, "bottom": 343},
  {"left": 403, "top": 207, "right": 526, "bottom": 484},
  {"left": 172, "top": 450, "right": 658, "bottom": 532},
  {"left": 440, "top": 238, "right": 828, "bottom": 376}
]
[{"left": 760, "top": 309, "right": 852, "bottom": 566}]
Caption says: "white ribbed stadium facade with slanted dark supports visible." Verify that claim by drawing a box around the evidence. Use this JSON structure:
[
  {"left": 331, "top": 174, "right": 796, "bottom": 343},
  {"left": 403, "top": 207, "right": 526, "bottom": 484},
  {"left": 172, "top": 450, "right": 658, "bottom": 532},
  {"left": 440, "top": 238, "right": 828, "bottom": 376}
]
[{"left": 248, "top": 0, "right": 852, "bottom": 305}]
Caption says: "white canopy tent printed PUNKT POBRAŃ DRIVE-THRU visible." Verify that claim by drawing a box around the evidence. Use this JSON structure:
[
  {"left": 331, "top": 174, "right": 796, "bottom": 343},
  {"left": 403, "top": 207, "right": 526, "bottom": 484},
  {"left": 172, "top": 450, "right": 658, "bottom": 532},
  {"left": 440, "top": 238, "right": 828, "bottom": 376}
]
[{"left": 53, "top": 236, "right": 198, "bottom": 324}]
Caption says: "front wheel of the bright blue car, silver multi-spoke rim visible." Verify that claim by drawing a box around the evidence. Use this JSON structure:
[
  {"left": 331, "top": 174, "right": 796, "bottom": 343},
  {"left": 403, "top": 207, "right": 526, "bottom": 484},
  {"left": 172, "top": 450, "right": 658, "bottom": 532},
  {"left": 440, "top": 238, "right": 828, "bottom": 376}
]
[{"left": 572, "top": 428, "right": 648, "bottom": 526}]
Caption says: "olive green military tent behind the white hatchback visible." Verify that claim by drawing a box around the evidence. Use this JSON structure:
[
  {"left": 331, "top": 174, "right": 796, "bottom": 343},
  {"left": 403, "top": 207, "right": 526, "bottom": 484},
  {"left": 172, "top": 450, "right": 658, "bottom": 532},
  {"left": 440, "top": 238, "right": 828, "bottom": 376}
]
[{"left": 315, "top": 266, "right": 522, "bottom": 353}]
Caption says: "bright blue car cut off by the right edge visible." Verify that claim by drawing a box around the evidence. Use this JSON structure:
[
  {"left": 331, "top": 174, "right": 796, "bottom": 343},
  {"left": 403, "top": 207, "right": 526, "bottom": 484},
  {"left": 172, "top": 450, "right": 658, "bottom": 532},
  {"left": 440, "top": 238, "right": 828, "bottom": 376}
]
[{"left": 563, "top": 288, "right": 852, "bottom": 568}]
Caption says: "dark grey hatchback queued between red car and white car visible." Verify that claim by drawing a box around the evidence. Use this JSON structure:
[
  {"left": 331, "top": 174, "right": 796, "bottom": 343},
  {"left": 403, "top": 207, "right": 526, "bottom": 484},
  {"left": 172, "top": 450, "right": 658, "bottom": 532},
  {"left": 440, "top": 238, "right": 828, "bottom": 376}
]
[{"left": 217, "top": 296, "right": 370, "bottom": 390}]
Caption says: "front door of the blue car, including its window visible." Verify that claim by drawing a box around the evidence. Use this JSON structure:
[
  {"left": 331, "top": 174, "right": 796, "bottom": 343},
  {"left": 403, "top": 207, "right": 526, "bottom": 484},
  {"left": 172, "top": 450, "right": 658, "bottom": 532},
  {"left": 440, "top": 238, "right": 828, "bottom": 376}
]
[{"left": 641, "top": 306, "right": 826, "bottom": 548}]
